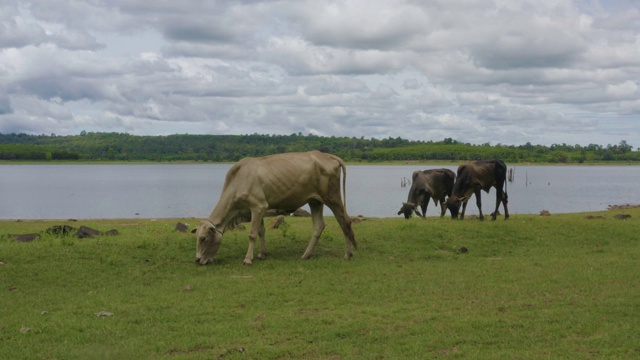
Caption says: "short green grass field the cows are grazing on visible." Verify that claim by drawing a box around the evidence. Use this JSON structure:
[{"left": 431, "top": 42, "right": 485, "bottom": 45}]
[{"left": 0, "top": 208, "right": 640, "bottom": 359}]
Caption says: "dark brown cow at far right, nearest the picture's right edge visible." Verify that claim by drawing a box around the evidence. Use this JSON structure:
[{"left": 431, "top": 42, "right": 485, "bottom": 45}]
[{"left": 447, "top": 159, "right": 509, "bottom": 220}]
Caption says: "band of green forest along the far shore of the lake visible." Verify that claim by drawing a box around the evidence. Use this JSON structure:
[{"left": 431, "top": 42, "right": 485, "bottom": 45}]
[{"left": 0, "top": 131, "right": 640, "bottom": 164}]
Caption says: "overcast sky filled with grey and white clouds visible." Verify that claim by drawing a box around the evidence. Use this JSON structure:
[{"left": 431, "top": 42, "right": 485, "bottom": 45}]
[{"left": 0, "top": 0, "right": 640, "bottom": 149}]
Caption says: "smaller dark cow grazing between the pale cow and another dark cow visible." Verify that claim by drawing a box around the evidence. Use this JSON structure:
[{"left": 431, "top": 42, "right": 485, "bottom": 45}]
[{"left": 398, "top": 169, "right": 456, "bottom": 219}]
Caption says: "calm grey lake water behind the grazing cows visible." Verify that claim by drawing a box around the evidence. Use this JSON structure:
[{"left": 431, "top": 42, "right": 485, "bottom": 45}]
[{"left": 0, "top": 164, "right": 640, "bottom": 219}]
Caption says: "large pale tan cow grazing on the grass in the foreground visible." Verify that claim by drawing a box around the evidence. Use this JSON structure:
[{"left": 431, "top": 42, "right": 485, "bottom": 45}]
[{"left": 192, "top": 151, "right": 357, "bottom": 265}]
